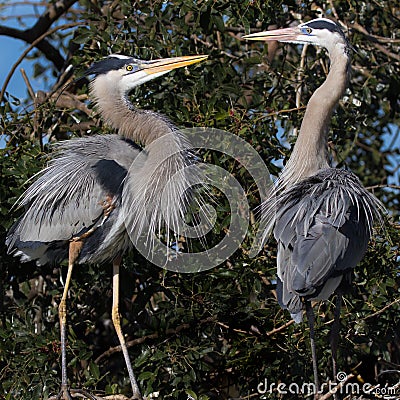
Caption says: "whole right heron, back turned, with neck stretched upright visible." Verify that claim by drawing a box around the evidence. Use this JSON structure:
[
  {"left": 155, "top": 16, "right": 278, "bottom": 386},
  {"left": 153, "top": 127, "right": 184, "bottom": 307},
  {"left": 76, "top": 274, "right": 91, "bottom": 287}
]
[{"left": 244, "top": 18, "right": 382, "bottom": 396}]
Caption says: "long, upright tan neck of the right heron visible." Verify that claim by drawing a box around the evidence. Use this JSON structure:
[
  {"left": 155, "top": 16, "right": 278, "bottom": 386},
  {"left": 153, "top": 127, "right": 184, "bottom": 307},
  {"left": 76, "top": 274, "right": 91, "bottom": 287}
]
[{"left": 280, "top": 44, "right": 350, "bottom": 187}]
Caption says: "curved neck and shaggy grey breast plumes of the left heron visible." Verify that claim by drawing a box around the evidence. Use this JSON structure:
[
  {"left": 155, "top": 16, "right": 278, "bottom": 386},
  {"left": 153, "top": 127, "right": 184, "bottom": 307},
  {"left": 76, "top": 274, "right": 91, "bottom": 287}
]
[{"left": 90, "top": 76, "right": 198, "bottom": 248}]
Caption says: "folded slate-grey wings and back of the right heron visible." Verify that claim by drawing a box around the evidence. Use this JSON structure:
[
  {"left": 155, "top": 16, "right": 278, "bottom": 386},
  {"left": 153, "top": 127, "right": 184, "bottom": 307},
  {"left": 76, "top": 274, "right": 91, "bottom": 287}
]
[{"left": 274, "top": 169, "right": 378, "bottom": 313}]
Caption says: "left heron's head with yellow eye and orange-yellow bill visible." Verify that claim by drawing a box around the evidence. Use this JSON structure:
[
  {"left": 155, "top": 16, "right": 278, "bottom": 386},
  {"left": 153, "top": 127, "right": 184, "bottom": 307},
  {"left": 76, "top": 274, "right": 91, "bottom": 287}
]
[{"left": 86, "top": 54, "right": 208, "bottom": 93}]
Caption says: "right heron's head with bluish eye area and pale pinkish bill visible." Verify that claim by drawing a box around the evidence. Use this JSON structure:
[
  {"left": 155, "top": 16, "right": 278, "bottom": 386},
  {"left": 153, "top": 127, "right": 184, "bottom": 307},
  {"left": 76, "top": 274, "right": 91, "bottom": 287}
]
[{"left": 243, "top": 18, "right": 348, "bottom": 51}]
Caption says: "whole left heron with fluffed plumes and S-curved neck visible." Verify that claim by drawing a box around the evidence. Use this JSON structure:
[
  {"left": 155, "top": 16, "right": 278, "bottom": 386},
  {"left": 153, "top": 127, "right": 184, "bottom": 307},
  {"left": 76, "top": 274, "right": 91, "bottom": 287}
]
[{"left": 7, "top": 55, "right": 207, "bottom": 399}]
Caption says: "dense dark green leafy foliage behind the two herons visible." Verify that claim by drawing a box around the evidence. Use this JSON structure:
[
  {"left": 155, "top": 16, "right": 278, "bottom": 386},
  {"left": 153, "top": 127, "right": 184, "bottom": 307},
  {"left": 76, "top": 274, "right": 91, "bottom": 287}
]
[{"left": 0, "top": 0, "right": 400, "bottom": 400}]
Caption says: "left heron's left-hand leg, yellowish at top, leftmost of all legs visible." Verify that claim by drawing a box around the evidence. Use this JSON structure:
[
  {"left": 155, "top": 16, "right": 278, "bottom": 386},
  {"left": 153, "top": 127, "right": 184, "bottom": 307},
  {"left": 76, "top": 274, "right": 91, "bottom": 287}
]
[{"left": 57, "top": 241, "right": 83, "bottom": 400}]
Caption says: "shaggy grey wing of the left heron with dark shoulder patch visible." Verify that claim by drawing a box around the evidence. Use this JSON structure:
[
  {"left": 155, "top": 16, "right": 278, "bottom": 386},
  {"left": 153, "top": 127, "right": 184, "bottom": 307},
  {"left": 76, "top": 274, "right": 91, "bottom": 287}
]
[{"left": 7, "top": 135, "right": 139, "bottom": 253}]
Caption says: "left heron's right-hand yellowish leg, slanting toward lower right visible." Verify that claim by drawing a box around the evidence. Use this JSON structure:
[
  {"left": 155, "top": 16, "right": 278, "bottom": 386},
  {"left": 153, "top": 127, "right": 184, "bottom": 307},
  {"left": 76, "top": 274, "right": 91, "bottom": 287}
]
[{"left": 111, "top": 256, "right": 142, "bottom": 400}]
